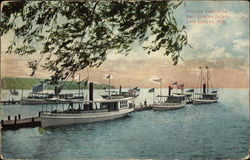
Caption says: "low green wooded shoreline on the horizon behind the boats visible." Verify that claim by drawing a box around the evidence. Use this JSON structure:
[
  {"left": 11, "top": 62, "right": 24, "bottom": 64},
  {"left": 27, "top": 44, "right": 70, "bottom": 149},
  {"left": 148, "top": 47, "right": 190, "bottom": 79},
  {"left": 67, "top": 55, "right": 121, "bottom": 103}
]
[{"left": 1, "top": 77, "right": 115, "bottom": 90}]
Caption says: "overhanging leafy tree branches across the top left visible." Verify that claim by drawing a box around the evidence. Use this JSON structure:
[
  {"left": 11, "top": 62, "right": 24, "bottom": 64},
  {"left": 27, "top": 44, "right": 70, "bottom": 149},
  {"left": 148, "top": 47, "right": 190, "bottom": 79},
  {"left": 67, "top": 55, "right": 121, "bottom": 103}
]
[{"left": 1, "top": 1, "right": 188, "bottom": 84}]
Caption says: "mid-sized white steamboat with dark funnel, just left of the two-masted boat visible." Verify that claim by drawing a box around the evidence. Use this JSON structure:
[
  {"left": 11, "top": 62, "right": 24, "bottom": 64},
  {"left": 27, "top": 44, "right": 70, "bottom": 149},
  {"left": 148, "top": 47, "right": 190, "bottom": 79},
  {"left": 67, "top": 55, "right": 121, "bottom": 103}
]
[{"left": 152, "top": 86, "right": 187, "bottom": 111}]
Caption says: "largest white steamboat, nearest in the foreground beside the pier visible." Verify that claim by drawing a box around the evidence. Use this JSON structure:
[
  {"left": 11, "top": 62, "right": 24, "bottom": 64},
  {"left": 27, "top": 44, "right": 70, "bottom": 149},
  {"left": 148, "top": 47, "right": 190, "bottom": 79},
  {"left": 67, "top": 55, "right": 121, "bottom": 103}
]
[{"left": 41, "top": 97, "right": 134, "bottom": 128}]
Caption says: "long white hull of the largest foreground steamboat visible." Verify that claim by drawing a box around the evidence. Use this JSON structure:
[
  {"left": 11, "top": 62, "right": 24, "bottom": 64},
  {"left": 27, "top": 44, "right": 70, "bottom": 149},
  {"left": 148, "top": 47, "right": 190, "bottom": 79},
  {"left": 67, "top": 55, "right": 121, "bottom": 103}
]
[{"left": 41, "top": 108, "right": 134, "bottom": 127}]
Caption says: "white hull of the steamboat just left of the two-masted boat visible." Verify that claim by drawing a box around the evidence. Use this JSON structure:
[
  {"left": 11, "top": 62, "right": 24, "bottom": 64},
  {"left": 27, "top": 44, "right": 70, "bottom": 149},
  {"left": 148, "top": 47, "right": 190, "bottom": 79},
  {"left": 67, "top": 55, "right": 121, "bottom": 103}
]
[{"left": 152, "top": 103, "right": 186, "bottom": 111}]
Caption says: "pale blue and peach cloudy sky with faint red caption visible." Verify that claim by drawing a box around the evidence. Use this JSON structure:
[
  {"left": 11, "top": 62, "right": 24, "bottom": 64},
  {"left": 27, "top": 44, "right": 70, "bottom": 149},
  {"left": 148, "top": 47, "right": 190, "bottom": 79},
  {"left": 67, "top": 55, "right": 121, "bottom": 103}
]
[{"left": 1, "top": 1, "right": 249, "bottom": 88}]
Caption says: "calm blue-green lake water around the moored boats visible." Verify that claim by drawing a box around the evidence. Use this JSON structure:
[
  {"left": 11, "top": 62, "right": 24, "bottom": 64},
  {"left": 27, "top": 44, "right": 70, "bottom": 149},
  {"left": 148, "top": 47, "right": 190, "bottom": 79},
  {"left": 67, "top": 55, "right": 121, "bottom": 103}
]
[{"left": 1, "top": 89, "right": 249, "bottom": 159}]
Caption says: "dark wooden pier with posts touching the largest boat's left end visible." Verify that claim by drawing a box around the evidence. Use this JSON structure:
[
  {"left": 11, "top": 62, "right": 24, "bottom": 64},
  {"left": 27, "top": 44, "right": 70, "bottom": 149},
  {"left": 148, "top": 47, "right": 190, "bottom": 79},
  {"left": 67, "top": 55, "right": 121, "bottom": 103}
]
[{"left": 1, "top": 114, "right": 41, "bottom": 130}]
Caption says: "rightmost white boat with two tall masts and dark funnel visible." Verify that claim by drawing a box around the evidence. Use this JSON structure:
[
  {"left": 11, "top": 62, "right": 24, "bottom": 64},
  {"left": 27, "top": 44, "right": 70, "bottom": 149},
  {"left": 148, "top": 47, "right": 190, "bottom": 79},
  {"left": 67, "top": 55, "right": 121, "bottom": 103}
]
[{"left": 193, "top": 66, "right": 219, "bottom": 104}]
